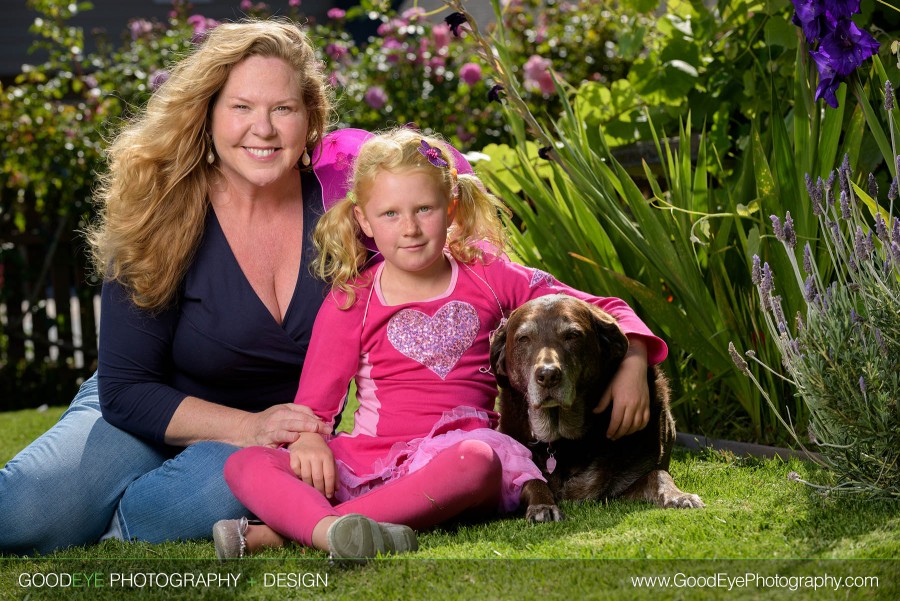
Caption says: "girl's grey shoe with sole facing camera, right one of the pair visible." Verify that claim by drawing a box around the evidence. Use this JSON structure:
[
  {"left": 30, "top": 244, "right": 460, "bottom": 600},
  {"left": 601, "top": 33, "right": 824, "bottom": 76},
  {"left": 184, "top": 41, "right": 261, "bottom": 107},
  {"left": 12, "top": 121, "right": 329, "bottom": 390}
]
[{"left": 328, "top": 513, "right": 419, "bottom": 559}]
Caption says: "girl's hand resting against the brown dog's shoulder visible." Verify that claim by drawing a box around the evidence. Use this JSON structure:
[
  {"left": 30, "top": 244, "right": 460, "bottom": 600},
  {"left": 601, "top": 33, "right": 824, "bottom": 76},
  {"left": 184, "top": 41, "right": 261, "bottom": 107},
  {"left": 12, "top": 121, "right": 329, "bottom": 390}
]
[{"left": 594, "top": 337, "right": 650, "bottom": 440}]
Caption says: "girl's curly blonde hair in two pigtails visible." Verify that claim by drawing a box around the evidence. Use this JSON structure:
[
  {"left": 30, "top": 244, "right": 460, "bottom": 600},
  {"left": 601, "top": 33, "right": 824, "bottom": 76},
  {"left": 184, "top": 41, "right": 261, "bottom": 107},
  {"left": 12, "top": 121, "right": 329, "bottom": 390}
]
[{"left": 312, "top": 128, "right": 509, "bottom": 308}]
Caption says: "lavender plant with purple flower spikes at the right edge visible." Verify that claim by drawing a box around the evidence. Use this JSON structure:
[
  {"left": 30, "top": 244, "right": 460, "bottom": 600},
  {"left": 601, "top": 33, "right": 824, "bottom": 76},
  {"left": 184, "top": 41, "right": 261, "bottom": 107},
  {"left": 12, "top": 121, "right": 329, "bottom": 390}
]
[{"left": 729, "top": 82, "right": 900, "bottom": 498}]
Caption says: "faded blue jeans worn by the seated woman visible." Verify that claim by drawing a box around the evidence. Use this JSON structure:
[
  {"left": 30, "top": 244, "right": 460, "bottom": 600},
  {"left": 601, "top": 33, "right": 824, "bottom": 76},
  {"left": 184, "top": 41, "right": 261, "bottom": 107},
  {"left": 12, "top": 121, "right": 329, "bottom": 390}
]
[{"left": 0, "top": 375, "right": 247, "bottom": 554}]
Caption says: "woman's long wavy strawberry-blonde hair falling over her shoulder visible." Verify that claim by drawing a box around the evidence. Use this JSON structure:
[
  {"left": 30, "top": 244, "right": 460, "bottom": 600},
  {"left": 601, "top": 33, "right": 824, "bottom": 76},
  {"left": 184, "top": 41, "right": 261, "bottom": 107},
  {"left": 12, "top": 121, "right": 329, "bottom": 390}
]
[{"left": 86, "top": 19, "right": 331, "bottom": 310}]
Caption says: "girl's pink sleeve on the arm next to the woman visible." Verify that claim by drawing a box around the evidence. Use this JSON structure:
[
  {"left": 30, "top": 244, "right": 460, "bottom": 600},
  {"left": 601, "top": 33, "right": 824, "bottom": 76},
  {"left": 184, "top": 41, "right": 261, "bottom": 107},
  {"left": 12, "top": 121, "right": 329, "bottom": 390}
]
[{"left": 294, "top": 292, "right": 364, "bottom": 428}]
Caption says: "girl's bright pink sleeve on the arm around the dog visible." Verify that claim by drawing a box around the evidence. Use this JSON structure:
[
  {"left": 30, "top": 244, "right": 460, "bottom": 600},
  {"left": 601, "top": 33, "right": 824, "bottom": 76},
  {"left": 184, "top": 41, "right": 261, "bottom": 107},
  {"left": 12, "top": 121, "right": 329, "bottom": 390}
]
[{"left": 485, "top": 258, "right": 669, "bottom": 365}]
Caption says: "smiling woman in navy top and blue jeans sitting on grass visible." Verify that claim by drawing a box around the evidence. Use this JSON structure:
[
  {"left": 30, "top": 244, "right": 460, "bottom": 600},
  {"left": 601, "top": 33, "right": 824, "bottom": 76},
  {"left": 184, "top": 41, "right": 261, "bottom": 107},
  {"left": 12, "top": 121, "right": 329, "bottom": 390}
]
[{"left": 0, "top": 21, "right": 331, "bottom": 553}]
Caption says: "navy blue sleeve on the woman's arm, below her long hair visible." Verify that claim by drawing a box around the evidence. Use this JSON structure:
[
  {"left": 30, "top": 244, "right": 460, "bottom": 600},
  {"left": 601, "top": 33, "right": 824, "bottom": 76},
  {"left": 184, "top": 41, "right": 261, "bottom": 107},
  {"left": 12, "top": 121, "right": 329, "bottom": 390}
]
[{"left": 97, "top": 281, "right": 185, "bottom": 442}]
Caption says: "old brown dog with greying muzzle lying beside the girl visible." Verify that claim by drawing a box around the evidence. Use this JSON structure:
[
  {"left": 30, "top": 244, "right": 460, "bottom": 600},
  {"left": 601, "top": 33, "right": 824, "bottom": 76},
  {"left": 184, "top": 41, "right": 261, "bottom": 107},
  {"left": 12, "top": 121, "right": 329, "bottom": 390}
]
[{"left": 491, "top": 294, "right": 704, "bottom": 522}]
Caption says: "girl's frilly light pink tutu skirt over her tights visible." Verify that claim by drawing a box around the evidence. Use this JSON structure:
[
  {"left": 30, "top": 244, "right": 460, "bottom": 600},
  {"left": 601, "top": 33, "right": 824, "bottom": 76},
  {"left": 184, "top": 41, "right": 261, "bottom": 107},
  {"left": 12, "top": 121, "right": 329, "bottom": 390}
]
[{"left": 335, "top": 407, "right": 546, "bottom": 513}]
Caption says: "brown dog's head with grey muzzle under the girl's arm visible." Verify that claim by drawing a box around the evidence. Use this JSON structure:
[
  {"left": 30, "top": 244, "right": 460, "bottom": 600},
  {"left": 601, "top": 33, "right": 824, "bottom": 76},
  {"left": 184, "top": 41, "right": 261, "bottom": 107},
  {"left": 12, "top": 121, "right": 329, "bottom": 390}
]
[{"left": 491, "top": 294, "right": 628, "bottom": 442}]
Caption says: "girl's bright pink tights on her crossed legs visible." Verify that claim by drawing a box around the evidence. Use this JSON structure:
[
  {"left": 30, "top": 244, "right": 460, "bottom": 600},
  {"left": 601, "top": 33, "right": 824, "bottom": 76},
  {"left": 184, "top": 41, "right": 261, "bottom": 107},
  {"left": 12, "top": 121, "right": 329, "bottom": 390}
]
[{"left": 225, "top": 440, "right": 502, "bottom": 546}]
